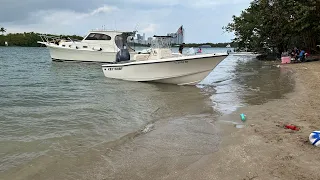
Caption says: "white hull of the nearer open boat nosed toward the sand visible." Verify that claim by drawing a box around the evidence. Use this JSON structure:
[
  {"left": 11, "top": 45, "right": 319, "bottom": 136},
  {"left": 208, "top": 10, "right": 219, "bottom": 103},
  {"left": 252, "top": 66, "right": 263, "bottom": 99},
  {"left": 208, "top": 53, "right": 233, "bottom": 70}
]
[{"left": 102, "top": 55, "right": 227, "bottom": 85}]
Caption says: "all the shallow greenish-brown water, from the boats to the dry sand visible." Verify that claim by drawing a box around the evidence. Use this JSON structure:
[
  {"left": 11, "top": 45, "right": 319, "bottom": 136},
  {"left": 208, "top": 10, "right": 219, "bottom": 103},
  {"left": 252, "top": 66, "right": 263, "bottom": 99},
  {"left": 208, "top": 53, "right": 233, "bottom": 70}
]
[{"left": 0, "top": 47, "right": 294, "bottom": 179}]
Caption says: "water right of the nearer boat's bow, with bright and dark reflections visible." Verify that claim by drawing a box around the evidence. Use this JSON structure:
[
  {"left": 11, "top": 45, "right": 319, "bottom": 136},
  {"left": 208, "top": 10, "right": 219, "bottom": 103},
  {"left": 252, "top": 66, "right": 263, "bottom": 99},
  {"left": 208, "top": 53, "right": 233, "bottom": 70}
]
[{"left": 200, "top": 56, "right": 294, "bottom": 113}]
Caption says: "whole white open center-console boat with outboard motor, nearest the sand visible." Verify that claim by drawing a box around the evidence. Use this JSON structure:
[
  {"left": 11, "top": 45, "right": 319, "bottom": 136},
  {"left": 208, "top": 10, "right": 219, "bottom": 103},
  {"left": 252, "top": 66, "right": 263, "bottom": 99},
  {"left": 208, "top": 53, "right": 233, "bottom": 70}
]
[{"left": 102, "top": 36, "right": 228, "bottom": 85}]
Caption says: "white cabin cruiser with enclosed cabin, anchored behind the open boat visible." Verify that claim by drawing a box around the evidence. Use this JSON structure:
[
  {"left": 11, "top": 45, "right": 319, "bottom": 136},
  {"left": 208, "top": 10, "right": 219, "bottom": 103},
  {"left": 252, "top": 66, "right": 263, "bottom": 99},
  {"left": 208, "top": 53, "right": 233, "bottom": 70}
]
[{"left": 38, "top": 30, "right": 135, "bottom": 63}]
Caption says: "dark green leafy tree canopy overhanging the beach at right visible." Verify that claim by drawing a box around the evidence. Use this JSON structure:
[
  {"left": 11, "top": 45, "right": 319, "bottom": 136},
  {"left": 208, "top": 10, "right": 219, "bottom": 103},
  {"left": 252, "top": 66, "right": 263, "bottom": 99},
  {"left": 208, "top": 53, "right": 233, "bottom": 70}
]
[{"left": 223, "top": 0, "right": 320, "bottom": 53}]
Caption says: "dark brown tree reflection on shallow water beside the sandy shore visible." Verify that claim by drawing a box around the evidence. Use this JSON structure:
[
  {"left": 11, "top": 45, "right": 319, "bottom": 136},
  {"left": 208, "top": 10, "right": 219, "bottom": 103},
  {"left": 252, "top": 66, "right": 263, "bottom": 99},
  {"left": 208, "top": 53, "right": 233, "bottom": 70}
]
[{"left": 236, "top": 61, "right": 294, "bottom": 105}]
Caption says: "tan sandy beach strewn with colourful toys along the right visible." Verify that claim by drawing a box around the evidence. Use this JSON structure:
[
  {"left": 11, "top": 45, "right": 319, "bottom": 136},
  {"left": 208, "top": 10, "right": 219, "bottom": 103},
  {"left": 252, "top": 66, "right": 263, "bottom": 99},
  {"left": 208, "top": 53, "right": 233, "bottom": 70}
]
[{"left": 165, "top": 62, "right": 320, "bottom": 180}]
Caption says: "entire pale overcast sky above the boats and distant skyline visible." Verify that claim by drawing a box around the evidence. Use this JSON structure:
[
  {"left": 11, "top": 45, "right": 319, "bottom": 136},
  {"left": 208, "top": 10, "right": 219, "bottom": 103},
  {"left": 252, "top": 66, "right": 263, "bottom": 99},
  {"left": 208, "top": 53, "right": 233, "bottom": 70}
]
[{"left": 0, "top": 0, "right": 251, "bottom": 43}]
